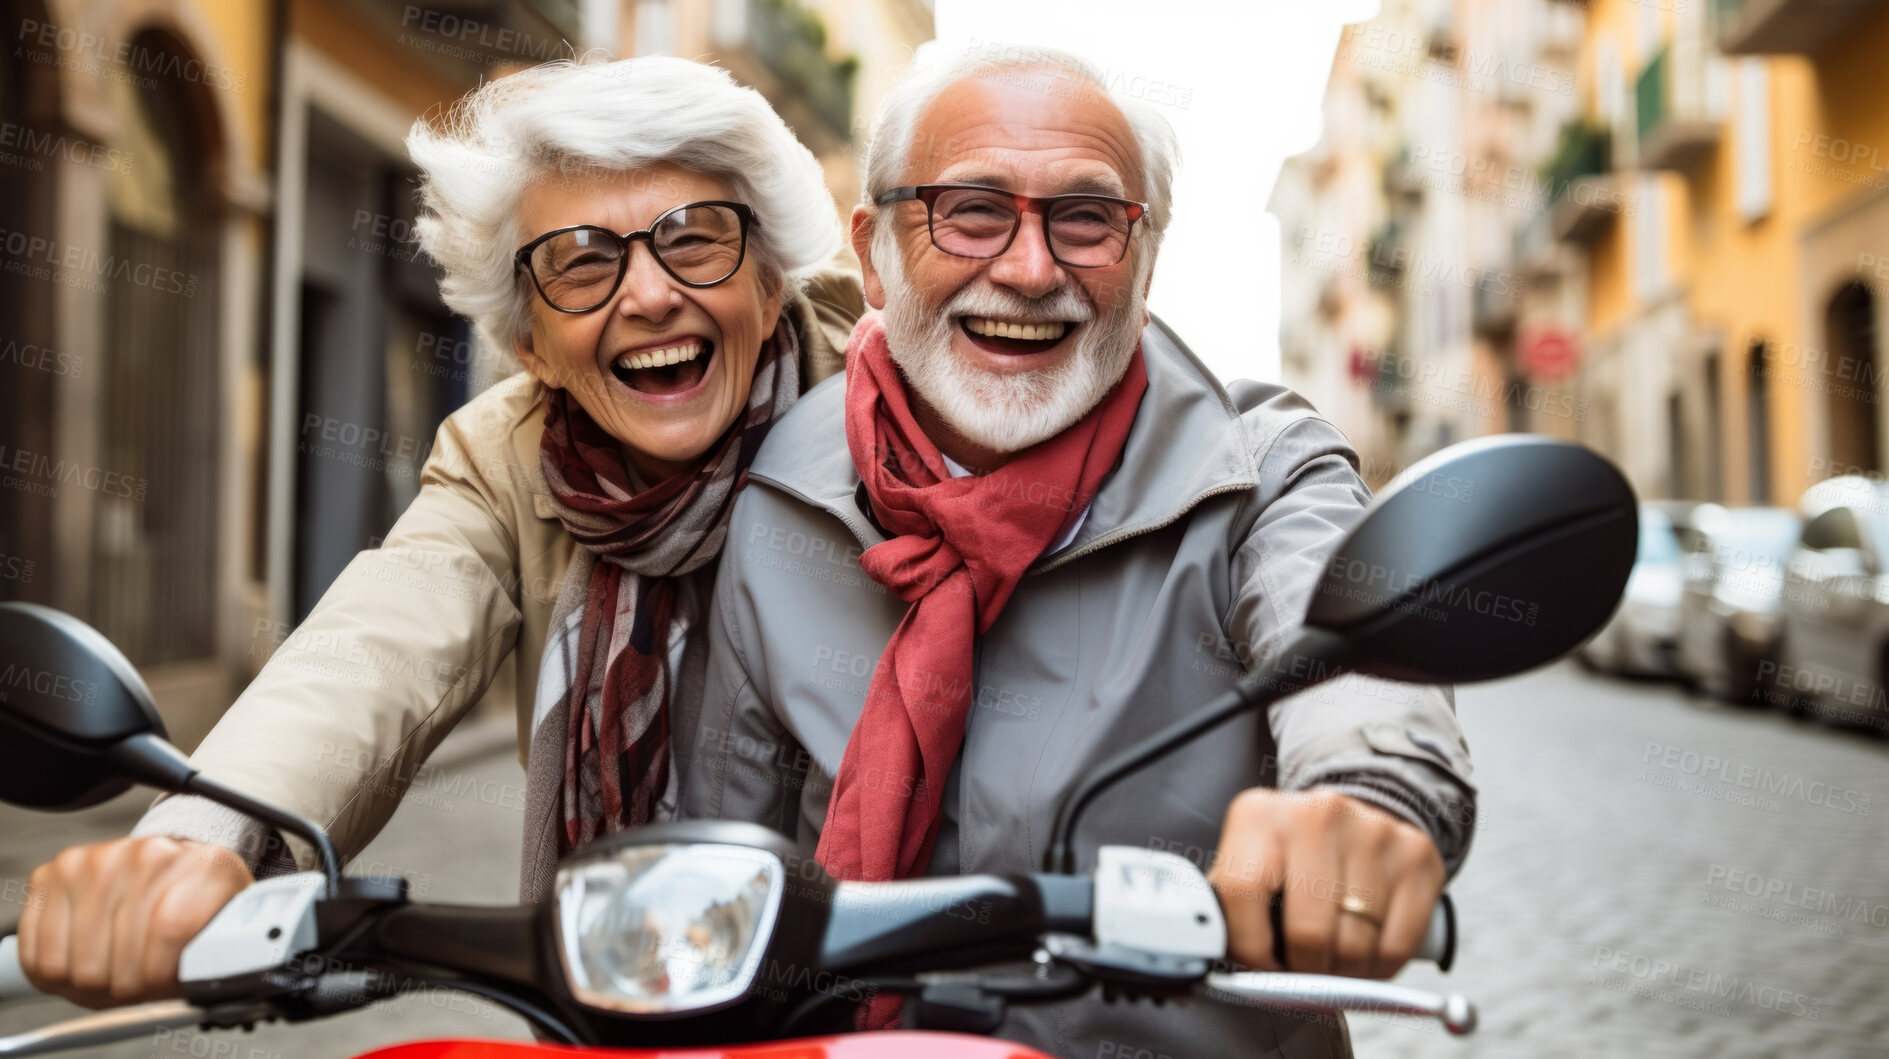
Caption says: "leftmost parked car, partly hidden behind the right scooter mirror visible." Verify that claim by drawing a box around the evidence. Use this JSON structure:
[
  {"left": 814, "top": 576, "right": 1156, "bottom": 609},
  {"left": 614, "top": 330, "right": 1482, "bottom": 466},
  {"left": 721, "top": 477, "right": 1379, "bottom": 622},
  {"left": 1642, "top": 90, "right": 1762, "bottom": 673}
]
[{"left": 1579, "top": 500, "right": 1698, "bottom": 676}]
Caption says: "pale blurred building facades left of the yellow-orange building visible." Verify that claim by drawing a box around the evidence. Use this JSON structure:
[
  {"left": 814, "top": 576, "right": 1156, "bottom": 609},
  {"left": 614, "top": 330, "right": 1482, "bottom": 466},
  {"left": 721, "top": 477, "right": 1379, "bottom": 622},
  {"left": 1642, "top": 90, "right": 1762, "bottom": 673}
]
[{"left": 1269, "top": 0, "right": 1581, "bottom": 485}]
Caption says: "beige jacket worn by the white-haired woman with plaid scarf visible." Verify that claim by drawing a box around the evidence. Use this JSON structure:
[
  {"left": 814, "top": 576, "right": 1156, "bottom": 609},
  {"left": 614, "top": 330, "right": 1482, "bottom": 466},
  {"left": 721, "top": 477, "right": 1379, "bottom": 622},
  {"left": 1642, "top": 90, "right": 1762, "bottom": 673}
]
[{"left": 132, "top": 266, "right": 865, "bottom": 870}]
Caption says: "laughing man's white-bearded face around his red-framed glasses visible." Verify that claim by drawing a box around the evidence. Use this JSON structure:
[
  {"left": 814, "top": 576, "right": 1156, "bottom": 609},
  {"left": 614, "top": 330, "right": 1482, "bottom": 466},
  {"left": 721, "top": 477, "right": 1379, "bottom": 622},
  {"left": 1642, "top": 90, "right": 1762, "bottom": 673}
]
[{"left": 854, "top": 77, "right": 1152, "bottom": 468}]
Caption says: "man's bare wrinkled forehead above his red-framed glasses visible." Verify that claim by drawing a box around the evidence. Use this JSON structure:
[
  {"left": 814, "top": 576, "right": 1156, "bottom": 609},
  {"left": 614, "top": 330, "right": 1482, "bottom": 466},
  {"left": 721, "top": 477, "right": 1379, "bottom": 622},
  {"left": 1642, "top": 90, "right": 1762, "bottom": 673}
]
[{"left": 903, "top": 70, "right": 1145, "bottom": 200}]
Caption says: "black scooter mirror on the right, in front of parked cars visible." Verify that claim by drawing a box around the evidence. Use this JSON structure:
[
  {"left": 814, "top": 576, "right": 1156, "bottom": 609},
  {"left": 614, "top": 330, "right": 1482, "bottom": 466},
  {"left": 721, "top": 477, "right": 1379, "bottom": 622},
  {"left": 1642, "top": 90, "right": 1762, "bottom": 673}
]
[{"left": 1305, "top": 434, "right": 1640, "bottom": 683}]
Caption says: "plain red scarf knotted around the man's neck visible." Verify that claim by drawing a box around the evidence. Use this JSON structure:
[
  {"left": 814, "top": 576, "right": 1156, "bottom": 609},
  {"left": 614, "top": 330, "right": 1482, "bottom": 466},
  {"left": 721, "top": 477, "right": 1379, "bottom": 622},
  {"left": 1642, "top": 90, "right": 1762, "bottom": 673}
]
[{"left": 816, "top": 313, "right": 1149, "bottom": 883}]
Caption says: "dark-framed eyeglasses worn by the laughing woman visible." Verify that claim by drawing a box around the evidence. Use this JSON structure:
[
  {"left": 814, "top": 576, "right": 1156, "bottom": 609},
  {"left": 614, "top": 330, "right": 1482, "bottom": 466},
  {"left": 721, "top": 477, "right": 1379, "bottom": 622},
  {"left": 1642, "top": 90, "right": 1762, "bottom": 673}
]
[{"left": 514, "top": 202, "right": 754, "bottom": 313}]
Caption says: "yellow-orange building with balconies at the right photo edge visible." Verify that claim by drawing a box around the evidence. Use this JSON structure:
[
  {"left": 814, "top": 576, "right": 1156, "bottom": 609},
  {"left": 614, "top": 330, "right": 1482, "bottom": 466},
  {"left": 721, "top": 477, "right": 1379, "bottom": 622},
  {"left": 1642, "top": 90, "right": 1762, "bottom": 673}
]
[{"left": 1583, "top": 0, "right": 1889, "bottom": 504}]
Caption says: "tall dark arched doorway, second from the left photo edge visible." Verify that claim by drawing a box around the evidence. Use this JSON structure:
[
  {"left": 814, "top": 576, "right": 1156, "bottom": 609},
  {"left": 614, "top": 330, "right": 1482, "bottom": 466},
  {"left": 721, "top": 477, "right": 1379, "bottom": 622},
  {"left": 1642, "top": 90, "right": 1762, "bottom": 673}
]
[{"left": 91, "top": 30, "right": 223, "bottom": 666}]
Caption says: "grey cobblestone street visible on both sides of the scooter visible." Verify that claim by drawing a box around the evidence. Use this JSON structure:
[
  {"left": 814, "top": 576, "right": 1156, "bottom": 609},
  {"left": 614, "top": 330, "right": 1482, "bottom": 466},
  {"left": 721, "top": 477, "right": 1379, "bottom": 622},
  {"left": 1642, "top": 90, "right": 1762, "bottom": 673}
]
[{"left": 0, "top": 664, "right": 1889, "bottom": 1059}]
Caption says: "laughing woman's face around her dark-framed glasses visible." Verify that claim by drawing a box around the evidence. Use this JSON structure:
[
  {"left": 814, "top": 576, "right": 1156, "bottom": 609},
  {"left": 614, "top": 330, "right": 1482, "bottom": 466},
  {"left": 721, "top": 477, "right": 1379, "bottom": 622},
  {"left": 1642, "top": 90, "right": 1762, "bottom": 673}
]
[{"left": 518, "top": 166, "right": 780, "bottom": 483}]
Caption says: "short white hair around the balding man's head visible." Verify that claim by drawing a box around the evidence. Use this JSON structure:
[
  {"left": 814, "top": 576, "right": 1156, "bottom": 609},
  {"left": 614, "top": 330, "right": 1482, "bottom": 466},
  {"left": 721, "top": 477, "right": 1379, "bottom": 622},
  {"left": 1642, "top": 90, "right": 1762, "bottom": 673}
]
[{"left": 863, "top": 43, "right": 1181, "bottom": 249}]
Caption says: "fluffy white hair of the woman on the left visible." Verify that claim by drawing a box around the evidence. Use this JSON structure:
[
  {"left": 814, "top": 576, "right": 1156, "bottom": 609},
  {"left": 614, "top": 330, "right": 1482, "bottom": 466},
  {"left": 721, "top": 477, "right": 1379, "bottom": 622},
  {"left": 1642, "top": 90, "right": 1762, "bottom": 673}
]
[{"left": 406, "top": 55, "right": 841, "bottom": 355}]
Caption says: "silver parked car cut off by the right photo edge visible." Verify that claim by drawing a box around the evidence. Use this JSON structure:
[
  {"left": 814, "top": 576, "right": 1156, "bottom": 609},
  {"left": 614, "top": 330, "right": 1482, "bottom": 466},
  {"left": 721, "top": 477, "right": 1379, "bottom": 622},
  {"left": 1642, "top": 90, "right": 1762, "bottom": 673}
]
[{"left": 1774, "top": 476, "right": 1889, "bottom": 732}]
